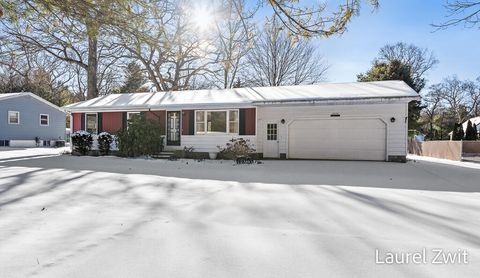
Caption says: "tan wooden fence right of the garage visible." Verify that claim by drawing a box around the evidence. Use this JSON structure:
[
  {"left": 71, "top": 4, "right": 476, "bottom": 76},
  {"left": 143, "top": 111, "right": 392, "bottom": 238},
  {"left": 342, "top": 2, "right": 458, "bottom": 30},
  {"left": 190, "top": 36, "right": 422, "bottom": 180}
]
[{"left": 408, "top": 140, "right": 480, "bottom": 161}]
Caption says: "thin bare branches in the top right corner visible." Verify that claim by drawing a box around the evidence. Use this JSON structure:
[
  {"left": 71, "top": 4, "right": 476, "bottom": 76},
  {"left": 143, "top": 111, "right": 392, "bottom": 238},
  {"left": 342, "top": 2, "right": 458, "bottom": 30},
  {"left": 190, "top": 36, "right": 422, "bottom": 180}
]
[{"left": 432, "top": 0, "right": 480, "bottom": 29}]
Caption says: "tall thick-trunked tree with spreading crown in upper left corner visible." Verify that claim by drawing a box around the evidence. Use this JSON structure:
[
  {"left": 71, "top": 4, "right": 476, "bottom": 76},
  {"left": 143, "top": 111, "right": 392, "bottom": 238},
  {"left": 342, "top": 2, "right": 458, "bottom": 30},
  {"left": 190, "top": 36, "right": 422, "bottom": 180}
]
[{"left": 1, "top": 0, "right": 152, "bottom": 98}]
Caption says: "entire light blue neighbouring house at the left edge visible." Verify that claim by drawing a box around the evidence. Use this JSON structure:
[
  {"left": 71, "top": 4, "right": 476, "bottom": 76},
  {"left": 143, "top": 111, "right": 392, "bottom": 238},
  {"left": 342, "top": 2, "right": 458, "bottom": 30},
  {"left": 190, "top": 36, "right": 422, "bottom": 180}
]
[{"left": 0, "top": 93, "right": 66, "bottom": 147}]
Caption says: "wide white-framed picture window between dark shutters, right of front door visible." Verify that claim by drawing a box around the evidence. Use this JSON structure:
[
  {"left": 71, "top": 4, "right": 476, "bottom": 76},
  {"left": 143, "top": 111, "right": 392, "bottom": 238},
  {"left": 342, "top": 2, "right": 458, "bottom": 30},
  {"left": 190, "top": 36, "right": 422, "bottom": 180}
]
[{"left": 195, "top": 110, "right": 238, "bottom": 134}]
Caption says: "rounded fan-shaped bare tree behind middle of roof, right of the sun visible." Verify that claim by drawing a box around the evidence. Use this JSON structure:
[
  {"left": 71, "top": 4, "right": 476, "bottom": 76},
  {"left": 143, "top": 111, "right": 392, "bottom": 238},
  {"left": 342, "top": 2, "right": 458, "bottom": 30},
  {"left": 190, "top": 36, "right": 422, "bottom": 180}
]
[{"left": 248, "top": 20, "right": 328, "bottom": 86}]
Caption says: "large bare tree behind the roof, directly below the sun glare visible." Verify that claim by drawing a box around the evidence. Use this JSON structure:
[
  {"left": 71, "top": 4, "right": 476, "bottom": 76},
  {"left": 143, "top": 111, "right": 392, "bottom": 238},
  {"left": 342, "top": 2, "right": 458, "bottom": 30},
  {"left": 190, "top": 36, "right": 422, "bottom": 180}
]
[{"left": 119, "top": 1, "right": 219, "bottom": 91}]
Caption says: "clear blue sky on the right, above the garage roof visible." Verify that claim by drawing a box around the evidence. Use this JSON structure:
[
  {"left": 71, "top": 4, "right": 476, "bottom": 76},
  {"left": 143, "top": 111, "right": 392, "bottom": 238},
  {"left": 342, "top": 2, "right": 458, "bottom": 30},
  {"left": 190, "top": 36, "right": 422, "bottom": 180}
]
[{"left": 256, "top": 0, "right": 480, "bottom": 85}]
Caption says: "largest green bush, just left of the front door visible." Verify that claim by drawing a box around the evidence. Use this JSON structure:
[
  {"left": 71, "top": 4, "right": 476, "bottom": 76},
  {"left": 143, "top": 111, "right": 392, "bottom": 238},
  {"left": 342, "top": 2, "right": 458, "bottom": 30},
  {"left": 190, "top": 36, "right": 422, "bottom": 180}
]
[{"left": 116, "top": 115, "right": 163, "bottom": 157}]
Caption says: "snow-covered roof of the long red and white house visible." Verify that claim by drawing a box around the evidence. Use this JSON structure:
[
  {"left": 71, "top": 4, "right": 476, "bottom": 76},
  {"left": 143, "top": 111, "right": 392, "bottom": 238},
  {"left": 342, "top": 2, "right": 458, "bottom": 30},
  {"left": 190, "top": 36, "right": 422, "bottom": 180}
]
[{"left": 65, "top": 81, "right": 419, "bottom": 111}]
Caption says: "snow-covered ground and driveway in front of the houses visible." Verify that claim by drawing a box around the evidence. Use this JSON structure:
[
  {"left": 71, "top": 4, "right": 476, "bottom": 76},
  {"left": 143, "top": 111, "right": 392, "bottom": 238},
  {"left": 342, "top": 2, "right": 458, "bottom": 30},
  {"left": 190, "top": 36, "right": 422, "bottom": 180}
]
[{"left": 0, "top": 149, "right": 480, "bottom": 277}]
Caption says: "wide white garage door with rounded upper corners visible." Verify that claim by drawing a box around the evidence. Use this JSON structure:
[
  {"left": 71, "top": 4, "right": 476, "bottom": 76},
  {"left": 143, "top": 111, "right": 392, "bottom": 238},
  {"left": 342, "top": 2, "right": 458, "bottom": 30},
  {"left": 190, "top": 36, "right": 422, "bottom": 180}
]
[{"left": 288, "top": 119, "right": 386, "bottom": 160}]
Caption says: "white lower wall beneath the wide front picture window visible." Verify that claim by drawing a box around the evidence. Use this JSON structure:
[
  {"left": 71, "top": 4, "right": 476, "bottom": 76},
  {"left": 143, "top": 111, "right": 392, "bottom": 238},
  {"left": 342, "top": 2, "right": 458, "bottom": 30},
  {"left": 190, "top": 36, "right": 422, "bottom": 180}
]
[{"left": 165, "top": 134, "right": 257, "bottom": 152}]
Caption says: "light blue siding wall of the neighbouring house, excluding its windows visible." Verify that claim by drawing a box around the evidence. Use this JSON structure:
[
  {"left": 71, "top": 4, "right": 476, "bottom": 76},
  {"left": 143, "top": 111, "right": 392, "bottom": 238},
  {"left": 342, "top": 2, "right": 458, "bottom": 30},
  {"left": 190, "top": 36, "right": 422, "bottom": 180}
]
[{"left": 0, "top": 95, "right": 66, "bottom": 140}]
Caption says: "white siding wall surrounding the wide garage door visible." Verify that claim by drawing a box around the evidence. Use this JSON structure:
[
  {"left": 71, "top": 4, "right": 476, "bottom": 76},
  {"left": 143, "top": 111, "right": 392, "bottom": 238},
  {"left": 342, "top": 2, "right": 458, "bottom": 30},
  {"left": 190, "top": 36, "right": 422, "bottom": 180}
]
[{"left": 257, "top": 103, "right": 408, "bottom": 159}]
